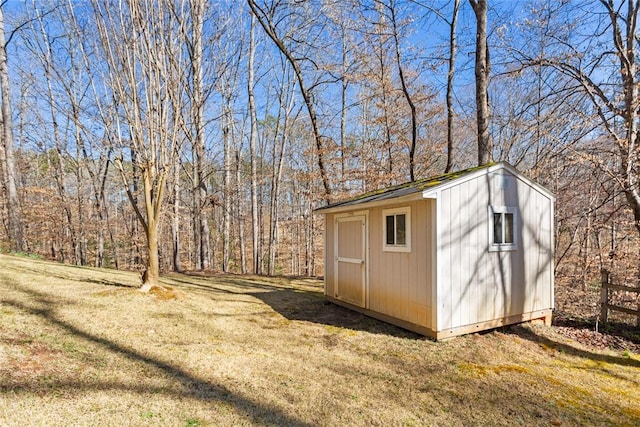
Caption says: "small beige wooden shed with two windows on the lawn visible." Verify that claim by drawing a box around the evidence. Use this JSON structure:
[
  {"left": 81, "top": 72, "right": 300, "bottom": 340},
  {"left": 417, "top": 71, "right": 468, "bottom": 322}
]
[{"left": 316, "top": 163, "right": 554, "bottom": 339}]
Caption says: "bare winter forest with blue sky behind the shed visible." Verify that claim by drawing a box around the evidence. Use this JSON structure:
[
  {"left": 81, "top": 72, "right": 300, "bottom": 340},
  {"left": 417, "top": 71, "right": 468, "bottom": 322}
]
[{"left": 0, "top": 0, "right": 640, "bottom": 310}]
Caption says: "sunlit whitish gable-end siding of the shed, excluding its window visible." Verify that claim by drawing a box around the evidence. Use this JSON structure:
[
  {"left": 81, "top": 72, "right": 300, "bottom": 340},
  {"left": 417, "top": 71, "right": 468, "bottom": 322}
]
[{"left": 436, "top": 171, "right": 553, "bottom": 330}]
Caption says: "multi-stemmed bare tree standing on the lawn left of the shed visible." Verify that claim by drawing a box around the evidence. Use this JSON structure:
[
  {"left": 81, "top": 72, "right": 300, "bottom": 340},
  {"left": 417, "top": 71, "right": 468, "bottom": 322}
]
[{"left": 92, "top": 0, "right": 188, "bottom": 291}]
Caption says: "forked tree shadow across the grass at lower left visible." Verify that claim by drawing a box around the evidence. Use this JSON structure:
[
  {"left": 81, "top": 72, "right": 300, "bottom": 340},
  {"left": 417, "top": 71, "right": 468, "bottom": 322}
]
[{"left": 0, "top": 286, "right": 312, "bottom": 426}]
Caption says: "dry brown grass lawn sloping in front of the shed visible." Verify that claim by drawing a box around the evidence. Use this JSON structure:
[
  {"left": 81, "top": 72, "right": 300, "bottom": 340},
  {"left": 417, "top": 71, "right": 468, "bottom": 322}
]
[{"left": 0, "top": 256, "right": 640, "bottom": 426}]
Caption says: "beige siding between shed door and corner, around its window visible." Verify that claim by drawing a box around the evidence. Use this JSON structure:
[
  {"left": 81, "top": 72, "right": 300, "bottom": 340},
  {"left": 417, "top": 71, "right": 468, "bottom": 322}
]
[{"left": 368, "top": 200, "right": 435, "bottom": 328}]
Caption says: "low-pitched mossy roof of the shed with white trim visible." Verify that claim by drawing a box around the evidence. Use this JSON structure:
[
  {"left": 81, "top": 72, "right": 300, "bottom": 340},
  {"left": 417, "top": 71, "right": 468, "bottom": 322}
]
[{"left": 316, "top": 162, "right": 553, "bottom": 213}]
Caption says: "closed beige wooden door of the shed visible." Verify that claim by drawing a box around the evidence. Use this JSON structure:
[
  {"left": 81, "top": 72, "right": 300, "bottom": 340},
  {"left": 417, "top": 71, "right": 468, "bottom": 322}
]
[{"left": 334, "top": 215, "right": 367, "bottom": 307}]
